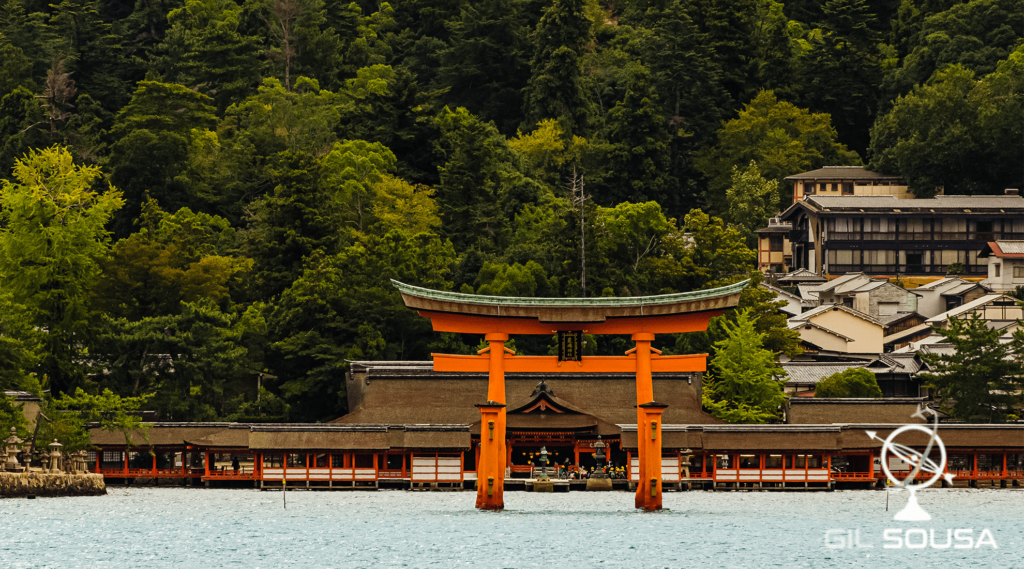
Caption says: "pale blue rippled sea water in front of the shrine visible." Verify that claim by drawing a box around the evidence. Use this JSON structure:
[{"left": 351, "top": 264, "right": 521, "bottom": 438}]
[{"left": 0, "top": 488, "right": 1024, "bottom": 569}]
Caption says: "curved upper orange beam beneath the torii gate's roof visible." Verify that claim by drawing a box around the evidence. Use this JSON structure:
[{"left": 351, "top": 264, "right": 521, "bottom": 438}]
[{"left": 420, "top": 309, "right": 725, "bottom": 336}]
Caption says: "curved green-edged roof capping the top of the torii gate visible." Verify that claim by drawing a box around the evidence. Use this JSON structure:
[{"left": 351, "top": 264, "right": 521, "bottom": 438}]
[{"left": 391, "top": 278, "right": 750, "bottom": 308}]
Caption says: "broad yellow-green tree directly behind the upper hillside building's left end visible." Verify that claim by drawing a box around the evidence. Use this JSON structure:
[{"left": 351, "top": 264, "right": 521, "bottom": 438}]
[{"left": 697, "top": 91, "right": 860, "bottom": 212}]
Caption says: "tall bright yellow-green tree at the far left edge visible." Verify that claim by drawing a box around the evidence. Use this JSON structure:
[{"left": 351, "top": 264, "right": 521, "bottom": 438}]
[{"left": 0, "top": 146, "right": 124, "bottom": 393}]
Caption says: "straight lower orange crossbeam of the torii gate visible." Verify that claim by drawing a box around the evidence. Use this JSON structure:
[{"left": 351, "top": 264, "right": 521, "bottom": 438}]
[{"left": 431, "top": 354, "right": 708, "bottom": 374}]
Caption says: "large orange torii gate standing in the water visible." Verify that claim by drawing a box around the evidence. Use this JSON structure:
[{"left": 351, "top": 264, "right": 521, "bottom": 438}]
[{"left": 391, "top": 280, "right": 748, "bottom": 511}]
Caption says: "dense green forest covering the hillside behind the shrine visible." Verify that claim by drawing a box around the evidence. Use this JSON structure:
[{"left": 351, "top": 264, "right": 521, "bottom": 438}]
[{"left": 0, "top": 0, "right": 1024, "bottom": 421}]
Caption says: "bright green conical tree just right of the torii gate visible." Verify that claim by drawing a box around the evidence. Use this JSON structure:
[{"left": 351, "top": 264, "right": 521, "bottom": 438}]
[{"left": 702, "top": 310, "right": 785, "bottom": 423}]
